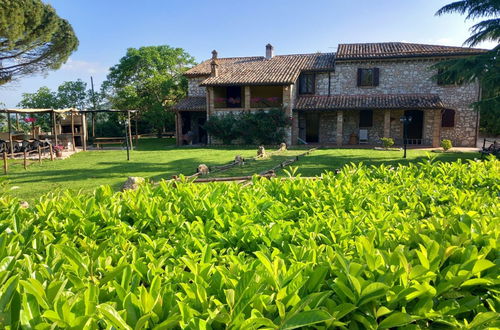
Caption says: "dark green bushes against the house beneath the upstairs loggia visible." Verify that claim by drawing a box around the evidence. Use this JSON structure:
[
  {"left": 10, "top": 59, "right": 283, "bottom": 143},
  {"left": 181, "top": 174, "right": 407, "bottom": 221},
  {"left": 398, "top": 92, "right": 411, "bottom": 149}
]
[{"left": 204, "top": 109, "right": 290, "bottom": 145}]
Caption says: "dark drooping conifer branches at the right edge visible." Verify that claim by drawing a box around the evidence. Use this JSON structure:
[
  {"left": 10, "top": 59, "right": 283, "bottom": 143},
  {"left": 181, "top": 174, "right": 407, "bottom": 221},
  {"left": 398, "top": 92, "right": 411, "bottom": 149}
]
[{"left": 435, "top": 0, "right": 500, "bottom": 135}]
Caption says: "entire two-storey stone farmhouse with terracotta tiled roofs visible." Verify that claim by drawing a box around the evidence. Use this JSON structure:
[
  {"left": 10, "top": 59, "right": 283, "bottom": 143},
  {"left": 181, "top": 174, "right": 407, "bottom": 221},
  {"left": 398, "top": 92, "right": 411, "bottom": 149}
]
[{"left": 174, "top": 42, "right": 484, "bottom": 147}]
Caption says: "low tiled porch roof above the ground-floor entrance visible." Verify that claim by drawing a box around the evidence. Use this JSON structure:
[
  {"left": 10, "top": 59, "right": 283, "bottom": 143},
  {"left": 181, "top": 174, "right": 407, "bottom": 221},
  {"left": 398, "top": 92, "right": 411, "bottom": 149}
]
[{"left": 294, "top": 94, "right": 445, "bottom": 110}]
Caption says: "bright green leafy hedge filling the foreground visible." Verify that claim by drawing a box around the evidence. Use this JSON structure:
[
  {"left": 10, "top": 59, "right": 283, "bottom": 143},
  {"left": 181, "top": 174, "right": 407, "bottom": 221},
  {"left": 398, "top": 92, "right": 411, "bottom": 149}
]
[{"left": 0, "top": 159, "right": 500, "bottom": 329}]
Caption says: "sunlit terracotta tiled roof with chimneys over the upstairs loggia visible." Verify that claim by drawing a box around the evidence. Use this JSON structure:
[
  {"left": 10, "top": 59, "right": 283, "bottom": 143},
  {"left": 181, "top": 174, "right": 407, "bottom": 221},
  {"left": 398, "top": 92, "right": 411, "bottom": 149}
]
[{"left": 185, "top": 53, "right": 335, "bottom": 86}]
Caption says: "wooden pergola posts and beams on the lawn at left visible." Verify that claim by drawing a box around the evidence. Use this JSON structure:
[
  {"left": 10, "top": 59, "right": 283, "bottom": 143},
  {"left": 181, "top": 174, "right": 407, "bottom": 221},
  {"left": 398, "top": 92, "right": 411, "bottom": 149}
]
[{"left": 0, "top": 108, "right": 137, "bottom": 160}]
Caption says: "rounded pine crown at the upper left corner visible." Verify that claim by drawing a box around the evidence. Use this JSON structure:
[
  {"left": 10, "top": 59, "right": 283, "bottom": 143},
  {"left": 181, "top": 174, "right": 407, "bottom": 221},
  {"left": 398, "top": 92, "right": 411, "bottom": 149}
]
[{"left": 0, "top": 0, "right": 78, "bottom": 85}]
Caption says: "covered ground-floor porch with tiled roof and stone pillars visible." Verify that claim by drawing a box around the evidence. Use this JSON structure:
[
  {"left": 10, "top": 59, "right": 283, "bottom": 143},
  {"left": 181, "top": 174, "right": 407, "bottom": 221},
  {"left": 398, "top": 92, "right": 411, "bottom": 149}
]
[{"left": 292, "top": 94, "right": 443, "bottom": 147}]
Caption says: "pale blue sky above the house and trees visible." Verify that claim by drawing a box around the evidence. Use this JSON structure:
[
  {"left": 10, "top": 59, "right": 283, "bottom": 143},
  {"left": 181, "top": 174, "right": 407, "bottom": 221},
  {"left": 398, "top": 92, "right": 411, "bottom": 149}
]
[{"left": 0, "top": 0, "right": 494, "bottom": 107}]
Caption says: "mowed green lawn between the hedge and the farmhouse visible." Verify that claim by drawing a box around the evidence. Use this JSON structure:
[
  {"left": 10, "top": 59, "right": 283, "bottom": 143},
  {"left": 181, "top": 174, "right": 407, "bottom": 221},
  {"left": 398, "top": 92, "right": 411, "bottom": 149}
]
[{"left": 0, "top": 139, "right": 479, "bottom": 200}]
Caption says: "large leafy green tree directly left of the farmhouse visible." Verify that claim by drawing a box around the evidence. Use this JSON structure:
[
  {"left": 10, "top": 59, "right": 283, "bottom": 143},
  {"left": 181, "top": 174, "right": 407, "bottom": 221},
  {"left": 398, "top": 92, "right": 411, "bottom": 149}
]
[{"left": 103, "top": 45, "right": 195, "bottom": 133}]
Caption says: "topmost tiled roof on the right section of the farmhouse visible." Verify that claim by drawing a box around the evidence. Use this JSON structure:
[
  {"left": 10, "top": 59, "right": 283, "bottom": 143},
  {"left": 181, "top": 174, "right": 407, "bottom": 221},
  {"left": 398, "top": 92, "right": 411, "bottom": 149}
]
[{"left": 336, "top": 42, "right": 487, "bottom": 61}]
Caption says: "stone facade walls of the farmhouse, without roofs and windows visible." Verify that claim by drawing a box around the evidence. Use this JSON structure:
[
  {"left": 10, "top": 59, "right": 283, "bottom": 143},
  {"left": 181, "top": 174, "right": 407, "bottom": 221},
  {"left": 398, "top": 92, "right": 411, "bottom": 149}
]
[{"left": 188, "top": 59, "right": 479, "bottom": 146}]
